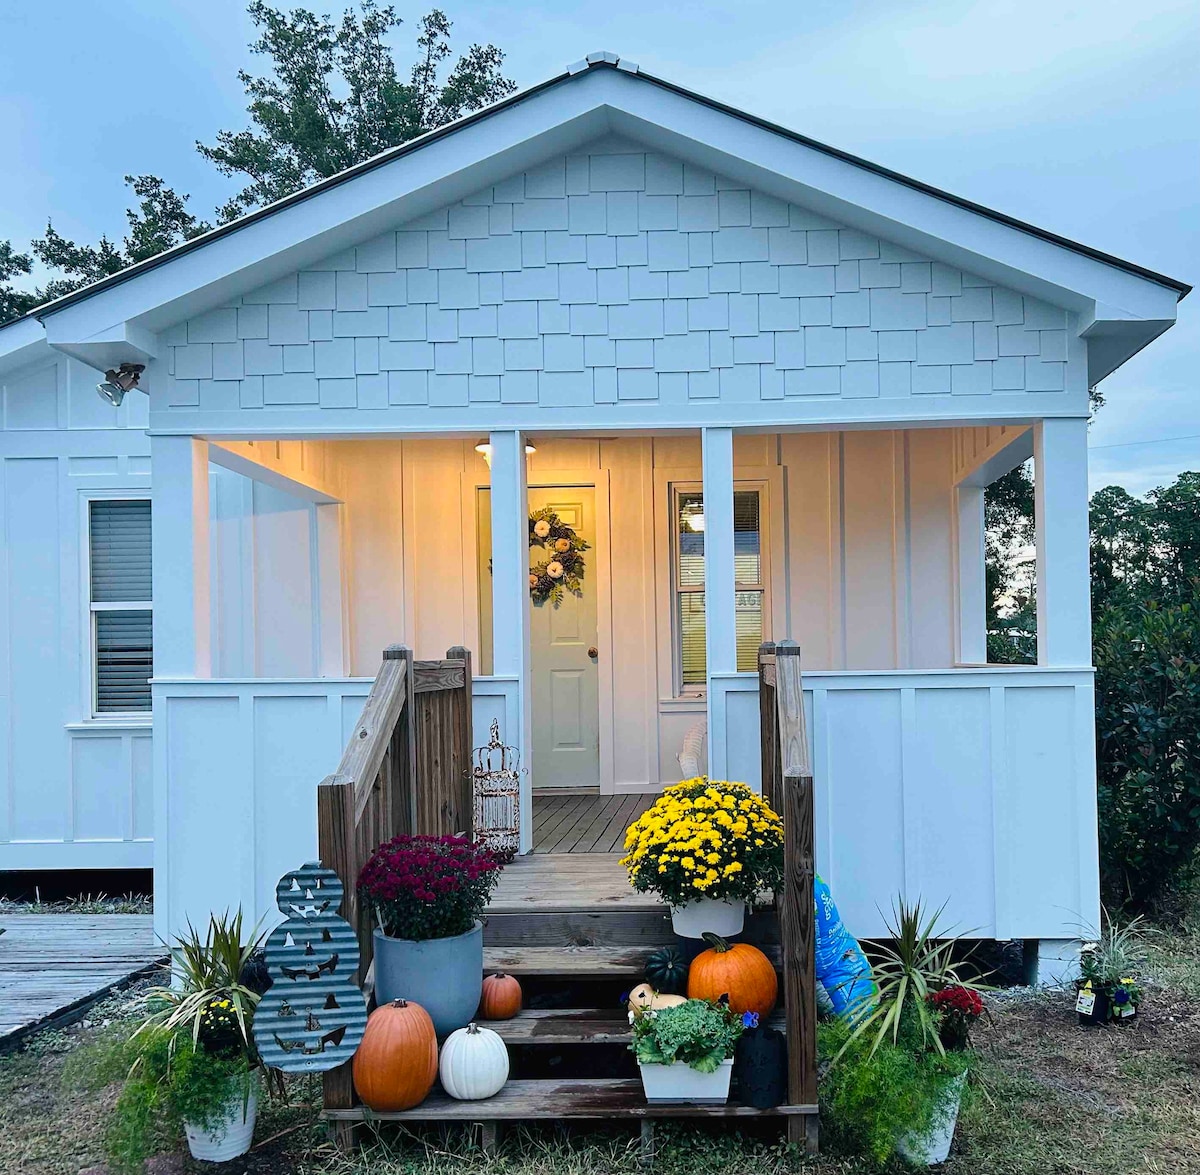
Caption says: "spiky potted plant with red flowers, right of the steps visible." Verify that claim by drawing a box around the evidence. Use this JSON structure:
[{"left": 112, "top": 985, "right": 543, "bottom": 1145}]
[{"left": 830, "top": 898, "right": 985, "bottom": 1165}]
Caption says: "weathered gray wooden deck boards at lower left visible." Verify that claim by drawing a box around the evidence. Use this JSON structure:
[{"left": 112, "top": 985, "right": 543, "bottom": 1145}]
[{"left": 0, "top": 913, "right": 166, "bottom": 1051}]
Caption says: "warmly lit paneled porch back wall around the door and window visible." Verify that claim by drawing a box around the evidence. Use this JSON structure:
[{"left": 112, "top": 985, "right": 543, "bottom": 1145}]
[{"left": 265, "top": 430, "right": 955, "bottom": 789}]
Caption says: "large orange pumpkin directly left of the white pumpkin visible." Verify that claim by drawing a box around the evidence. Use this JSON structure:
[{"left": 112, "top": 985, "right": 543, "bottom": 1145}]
[{"left": 354, "top": 1000, "right": 438, "bottom": 1114}]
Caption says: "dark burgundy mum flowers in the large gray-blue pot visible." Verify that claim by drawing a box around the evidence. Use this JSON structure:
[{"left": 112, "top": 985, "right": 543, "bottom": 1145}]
[{"left": 359, "top": 837, "right": 503, "bottom": 941}]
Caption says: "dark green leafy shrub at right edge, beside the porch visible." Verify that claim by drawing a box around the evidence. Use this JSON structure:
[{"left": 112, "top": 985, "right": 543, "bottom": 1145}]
[{"left": 1094, "top": 604, "right": 1200, "bottom": 913}]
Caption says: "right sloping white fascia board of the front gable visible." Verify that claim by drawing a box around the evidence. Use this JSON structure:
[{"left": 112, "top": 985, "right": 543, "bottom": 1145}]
[{"left": 610, "top": 72, "right": 1178, "bottom": 318}]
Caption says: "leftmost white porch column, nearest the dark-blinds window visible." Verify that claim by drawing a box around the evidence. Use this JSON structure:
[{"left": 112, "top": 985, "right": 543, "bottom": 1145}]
[{"left": 150, "top": 437, "right": 212, "bottom": 677}]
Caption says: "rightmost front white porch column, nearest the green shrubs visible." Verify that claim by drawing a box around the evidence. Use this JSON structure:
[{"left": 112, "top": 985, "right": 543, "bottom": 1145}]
[{"left": 1033, "top": 419, "right": 1092, "bottom": 666}]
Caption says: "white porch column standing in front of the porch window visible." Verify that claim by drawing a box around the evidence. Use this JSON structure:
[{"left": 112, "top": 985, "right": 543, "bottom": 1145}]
[{"left": 701, "top": 428, "right": 738, "bottom": 774}]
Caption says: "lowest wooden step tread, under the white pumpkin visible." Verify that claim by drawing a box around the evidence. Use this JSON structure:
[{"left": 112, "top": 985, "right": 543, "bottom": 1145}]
[{"left": 323, "top": 1078, "right": 817, "bottom": 1122}]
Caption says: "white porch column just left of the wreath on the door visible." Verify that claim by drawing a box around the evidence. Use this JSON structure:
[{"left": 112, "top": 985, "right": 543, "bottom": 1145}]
[{"left": 490, "top": 430, "right": 533, "bottom": 852}]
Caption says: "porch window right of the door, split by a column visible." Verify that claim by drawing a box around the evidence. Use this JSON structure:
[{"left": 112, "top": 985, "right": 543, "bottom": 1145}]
[{"left": 673, "top": 490, "right": 763, "bottom": 693}]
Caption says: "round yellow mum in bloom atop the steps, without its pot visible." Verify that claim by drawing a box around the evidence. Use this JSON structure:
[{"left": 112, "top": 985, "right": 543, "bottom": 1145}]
[{"left": 620, "top": 775, "right": 784, "bottom": 906}]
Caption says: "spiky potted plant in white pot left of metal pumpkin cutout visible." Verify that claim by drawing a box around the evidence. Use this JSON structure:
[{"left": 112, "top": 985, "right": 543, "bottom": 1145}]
[{"left": 101, "top": 911, "right": 262, "bottom": 1170}]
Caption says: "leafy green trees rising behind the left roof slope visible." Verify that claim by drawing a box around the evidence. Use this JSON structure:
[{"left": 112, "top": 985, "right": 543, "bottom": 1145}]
[{"left": 0, "top": 0, "right": 516, "bottom": 323}]
